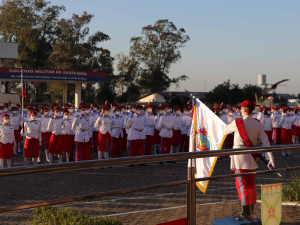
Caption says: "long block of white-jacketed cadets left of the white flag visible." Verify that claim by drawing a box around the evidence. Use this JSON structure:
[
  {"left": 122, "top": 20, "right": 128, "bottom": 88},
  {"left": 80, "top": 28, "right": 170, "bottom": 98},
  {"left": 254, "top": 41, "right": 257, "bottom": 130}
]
[{"left": 0, "top": 103, "right": 192, "bottom": 168}]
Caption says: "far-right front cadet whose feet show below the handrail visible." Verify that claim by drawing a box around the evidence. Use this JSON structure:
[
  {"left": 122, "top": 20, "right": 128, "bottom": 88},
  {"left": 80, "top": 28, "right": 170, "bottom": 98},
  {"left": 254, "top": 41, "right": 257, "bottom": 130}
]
[{"left": 280, "top": 107, "right": 294, "bottom": 157}]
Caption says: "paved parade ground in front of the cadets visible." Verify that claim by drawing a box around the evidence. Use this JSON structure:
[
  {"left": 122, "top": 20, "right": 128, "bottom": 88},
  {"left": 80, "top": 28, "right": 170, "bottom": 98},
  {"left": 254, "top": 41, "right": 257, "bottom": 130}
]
[{"left": 0, "top": 147, "right": 300, "bottom": 225}]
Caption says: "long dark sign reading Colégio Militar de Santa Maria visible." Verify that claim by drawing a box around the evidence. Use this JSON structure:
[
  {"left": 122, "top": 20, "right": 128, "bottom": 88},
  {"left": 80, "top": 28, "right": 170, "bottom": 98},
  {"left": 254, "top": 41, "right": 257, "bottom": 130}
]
[{"left": 0, "top": 67, "right": 107, "bottom": 83}]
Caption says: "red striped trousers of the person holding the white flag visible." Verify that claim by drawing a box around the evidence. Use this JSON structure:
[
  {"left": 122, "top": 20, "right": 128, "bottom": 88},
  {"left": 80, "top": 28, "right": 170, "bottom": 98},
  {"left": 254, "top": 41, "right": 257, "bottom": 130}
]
[{"left": 235, "top": 170, "right": 256, "bottom": 206}]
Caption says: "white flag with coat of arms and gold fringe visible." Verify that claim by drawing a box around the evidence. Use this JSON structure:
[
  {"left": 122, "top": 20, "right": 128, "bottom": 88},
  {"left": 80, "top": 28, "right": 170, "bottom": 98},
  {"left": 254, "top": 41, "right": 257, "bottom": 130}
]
[{"left": 189, "top": 98, "right": 226, "bottom": 193}]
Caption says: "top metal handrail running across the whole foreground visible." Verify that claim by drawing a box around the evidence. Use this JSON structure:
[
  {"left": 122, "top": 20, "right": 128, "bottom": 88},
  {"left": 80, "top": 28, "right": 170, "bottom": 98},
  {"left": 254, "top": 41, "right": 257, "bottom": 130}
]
[{"left": 0, "top": 145, "right": 300, "bottom": 177}]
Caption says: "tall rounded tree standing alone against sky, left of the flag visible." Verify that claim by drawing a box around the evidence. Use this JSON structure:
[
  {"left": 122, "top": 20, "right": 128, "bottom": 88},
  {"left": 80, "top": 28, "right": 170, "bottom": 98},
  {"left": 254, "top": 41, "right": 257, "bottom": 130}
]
[{"left": 130, "top": 20, "right": 190, "bottom": 93}]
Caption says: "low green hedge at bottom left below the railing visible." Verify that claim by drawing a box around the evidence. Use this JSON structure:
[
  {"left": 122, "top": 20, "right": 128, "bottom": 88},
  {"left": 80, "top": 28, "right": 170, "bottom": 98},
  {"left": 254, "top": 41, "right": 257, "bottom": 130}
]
[{"left": 31, "top": 206, "right": 122, "bottom": 225}]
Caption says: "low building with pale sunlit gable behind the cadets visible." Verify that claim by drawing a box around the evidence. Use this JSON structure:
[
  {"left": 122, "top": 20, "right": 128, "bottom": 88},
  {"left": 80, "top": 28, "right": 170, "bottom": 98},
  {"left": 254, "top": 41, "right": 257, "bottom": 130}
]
[{"left": 135, "top": 91, "right": 208, "bottom": 107}]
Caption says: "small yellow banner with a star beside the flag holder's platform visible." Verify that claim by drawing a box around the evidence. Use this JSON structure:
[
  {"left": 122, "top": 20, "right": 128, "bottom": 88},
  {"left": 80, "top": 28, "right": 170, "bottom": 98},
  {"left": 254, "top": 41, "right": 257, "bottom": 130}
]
[{"left": 261, "top": 184, "right": 282, "bottom": 225}]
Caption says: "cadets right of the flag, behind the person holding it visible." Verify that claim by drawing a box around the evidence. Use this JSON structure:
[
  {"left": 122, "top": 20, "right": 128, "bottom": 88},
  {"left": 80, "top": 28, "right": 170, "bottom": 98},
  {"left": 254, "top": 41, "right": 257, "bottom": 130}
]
[{"left": 210, "top": 105, "right": 300, "bottom": 157}]
